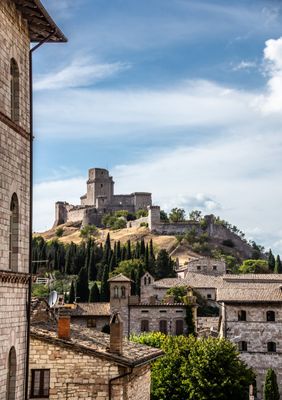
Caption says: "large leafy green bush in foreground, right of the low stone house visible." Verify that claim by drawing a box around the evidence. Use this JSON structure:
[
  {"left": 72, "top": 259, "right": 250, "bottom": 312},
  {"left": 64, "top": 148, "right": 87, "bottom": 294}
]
[{"left": 131, "top": 333, "right": 254, "bottom": 400}]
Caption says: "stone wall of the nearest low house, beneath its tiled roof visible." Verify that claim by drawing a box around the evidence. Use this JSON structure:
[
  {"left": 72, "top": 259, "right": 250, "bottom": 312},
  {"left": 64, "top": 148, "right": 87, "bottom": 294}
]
[{"left": 30, "top": 338, "right": 150, "bottom": 400}]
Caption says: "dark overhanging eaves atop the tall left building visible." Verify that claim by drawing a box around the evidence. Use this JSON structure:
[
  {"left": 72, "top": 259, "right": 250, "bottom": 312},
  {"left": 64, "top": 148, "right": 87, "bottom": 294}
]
[{"left": 12, "top": 0, "right": 67, "bottom": 42}]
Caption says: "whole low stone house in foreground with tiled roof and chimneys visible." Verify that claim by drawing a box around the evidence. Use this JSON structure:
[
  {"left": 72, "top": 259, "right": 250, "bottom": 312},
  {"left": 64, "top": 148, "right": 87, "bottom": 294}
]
[{"left": 29, "top": 304, "right": 163, "bottom": 400}]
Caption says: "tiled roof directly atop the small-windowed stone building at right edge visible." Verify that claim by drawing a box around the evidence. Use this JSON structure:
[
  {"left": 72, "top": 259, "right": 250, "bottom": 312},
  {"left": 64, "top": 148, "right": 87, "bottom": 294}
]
[{"left": 217, "top": 285, "right": 282, "bottom": 303}]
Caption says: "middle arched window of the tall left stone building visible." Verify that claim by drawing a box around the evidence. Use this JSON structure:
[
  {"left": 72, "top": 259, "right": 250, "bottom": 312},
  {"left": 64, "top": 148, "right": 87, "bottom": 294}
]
[{"left": 9, "top": 193, "right": 19, "bottom": 271}]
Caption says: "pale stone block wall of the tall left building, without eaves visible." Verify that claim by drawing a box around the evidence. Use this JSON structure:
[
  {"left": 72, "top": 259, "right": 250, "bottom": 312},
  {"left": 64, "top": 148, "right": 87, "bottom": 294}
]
[{"left": 0, "top": 0, "right": 30, "bottom": 400}]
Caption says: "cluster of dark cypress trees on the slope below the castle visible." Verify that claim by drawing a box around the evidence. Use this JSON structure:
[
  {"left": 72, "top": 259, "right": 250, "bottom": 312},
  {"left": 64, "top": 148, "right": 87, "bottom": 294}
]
[{"left": 32, "top": 233, "right": 174, "bottom": 302}]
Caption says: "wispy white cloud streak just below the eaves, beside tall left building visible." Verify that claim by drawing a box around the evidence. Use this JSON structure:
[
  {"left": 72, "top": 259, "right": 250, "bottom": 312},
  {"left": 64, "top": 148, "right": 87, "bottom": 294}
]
[{"left": 34, "top": 57, "right": 130, "bottom": 90}]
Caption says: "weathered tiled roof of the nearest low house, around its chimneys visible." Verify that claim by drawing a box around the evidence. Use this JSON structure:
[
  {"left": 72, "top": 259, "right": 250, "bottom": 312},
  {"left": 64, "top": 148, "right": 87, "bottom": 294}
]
[{"left": 31, "top": 324, "right": 163, "bottom": 367}]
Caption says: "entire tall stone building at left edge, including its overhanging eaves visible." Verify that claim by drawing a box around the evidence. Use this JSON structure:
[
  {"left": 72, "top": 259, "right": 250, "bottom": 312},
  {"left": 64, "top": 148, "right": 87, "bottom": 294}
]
[{"left": 0, "top": 0, "right": 66, "bottom": 400}]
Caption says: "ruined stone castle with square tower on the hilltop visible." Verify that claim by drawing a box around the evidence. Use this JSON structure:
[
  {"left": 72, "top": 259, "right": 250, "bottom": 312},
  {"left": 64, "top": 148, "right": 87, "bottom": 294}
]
[{"left": 54, "top": 168, "right": 152, "bottom": 226}]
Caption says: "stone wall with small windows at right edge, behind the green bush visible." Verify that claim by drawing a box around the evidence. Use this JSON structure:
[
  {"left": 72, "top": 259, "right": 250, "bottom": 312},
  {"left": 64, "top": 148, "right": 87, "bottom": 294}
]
[{"left": 223, "top": 303, "right": 282, "bottom": 399}]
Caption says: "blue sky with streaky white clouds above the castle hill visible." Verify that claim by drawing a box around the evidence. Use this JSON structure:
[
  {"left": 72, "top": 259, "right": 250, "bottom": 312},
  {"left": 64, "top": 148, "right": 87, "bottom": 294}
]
[{"left": 33, "top": 0, "right": 282, "bottom": 254}]
